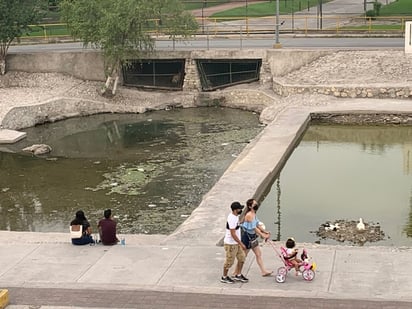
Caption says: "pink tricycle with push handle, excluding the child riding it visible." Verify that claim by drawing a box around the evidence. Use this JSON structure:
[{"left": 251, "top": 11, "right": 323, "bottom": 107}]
[{"left": 268, "top": 240, "right": 316, "bottom": 283}]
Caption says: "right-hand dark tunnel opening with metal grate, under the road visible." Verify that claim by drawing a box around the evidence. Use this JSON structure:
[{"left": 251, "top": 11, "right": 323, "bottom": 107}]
[{"left": 196, "top": 59, "right": 262, "bottom": 91}]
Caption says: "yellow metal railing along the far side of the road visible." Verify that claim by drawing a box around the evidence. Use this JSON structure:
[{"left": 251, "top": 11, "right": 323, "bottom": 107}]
[{"left": 22, "top": 14, "right": 412, "bottom": 42}]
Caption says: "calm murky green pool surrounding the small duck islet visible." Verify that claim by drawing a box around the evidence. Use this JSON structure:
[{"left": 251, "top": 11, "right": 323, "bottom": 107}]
[{"left": 259, "top": 125, "right": 412, "bottom": 246}]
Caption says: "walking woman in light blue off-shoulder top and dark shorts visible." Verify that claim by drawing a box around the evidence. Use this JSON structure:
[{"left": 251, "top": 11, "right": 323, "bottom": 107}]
[{"left": 241, "top": 199, "right": 272, "bottom": 277}]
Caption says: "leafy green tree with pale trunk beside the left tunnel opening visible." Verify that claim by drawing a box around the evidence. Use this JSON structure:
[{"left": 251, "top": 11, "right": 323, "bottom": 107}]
[{"left": 61, "top": 0, "right": 197, "bottom": 95}]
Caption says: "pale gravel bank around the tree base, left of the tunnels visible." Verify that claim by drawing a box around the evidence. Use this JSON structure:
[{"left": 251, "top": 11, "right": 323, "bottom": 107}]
[{"left": 0, "top": 71, "right": 192, "bottom": 123}]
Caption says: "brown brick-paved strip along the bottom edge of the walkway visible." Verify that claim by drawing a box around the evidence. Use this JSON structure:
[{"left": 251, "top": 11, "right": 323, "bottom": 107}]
[{"left": 8, "top": 288, "right": 411, "bottom": 309}]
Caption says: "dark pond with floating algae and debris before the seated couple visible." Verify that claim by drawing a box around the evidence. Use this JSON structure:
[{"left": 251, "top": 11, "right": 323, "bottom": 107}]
[{"left": 0, "top": 107, "right": 263, "bottom": 234}]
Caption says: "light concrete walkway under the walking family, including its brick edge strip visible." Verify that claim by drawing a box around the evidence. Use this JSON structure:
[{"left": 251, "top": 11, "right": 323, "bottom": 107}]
[{"left": 0, "top": 232, "right": 412, "bottom": 309}]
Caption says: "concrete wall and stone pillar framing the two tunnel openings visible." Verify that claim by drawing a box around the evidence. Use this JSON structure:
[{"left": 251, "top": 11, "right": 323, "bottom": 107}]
[{"left": 7, "top": 49, "right": 333, "bottom": 82}]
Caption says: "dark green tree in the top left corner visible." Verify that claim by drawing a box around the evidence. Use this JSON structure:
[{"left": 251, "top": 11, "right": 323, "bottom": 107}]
[{"left": 0, "top": 0, "right": 47, "bottom": 75}]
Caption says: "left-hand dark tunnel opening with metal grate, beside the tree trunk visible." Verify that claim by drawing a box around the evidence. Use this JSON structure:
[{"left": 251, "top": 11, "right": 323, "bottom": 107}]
[{"left": 122, "top": 59, "right": 185, "bottom": 90}]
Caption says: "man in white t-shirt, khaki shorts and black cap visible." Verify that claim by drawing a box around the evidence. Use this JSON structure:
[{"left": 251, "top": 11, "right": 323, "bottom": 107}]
[{"left": 220, "top": 202, "right": 249, "bottom": 283}]
